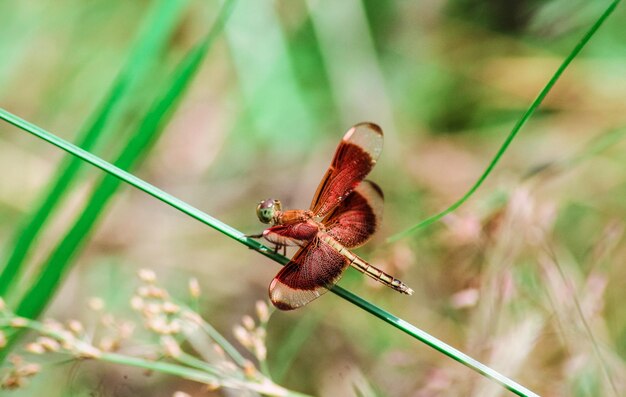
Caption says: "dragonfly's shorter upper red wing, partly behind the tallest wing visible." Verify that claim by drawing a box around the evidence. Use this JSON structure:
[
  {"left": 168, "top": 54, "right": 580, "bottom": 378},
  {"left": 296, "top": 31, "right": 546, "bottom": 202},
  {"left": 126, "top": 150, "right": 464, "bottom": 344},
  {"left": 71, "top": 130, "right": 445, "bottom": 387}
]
[{"left": 322, "top": 180, "right": 383, "bottom": 248}]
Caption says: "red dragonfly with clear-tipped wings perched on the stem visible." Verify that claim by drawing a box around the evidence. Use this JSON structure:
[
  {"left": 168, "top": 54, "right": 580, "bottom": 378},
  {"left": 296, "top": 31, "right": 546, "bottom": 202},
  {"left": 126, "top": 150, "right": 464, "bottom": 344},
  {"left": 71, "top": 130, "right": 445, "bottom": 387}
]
[{"left": 256, "top": 123, "right": 413, "bottom": 310}]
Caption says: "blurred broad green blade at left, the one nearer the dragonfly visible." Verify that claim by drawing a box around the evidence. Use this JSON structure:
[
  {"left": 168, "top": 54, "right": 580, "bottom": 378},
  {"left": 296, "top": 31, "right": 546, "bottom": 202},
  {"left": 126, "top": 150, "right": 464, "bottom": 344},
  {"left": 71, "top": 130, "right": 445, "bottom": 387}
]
[{"left": 16, "top": 0, "right": 239, "bottom": 318}]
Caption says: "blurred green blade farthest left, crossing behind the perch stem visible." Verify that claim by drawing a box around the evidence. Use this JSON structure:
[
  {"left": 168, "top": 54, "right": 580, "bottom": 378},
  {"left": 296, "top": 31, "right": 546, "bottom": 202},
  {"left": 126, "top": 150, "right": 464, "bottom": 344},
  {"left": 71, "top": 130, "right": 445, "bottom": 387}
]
[{"left": 0, "top": 0, "right": 186, "bottom": 297}]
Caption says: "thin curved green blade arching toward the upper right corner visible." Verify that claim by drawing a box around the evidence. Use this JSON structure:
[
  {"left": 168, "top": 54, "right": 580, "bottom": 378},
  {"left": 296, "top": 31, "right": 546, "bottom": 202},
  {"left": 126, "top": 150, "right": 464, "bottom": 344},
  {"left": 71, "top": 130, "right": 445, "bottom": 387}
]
[{"left": 387, "top": 0, "right": 621, "bottom": 242}]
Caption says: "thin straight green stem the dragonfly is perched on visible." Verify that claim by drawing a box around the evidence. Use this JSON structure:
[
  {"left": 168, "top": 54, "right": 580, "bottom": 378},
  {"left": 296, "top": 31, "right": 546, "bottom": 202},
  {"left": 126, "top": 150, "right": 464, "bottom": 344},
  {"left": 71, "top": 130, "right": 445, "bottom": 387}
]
[{"left": 0, "top": 108, "right": 537, "bottom": 397}]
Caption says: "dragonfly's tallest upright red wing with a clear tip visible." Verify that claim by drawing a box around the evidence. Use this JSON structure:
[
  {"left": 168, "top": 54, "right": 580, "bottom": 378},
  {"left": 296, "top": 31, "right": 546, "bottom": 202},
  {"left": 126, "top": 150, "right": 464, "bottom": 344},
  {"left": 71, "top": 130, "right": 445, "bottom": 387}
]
[{"left": 310, "top": 123, "right": 383, "bottom": 217}]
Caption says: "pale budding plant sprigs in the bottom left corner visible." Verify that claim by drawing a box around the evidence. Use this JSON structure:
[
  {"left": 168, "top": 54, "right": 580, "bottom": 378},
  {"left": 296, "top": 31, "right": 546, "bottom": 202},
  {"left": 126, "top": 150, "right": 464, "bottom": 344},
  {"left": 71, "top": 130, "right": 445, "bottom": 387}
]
[{"left": 0, "top": 269, "right": 304, "bottom": 397}]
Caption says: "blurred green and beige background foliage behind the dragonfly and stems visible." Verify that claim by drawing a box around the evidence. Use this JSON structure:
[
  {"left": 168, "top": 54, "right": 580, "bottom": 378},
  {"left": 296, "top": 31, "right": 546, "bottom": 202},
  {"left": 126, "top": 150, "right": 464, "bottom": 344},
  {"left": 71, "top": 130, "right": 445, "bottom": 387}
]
[{"left": 0, "top": 0, "right": 626, "bottom": 396}]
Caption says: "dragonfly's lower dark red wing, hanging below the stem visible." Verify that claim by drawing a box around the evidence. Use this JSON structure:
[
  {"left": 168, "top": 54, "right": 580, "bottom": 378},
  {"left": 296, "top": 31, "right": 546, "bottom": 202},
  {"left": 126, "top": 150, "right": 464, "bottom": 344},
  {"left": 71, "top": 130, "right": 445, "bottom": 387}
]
[{"left": 269, "top": 238, "right": 348, "bottom": 310}]
